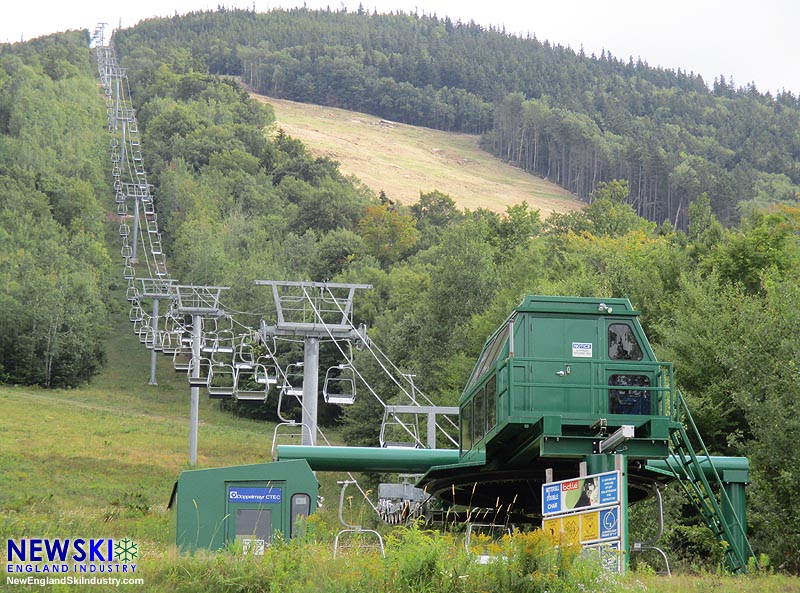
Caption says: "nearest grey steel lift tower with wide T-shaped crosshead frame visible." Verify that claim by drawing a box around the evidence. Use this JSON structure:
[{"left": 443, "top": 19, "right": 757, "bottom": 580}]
[{"left": 255, "top": 280, "right": 372, "bottom": 445}]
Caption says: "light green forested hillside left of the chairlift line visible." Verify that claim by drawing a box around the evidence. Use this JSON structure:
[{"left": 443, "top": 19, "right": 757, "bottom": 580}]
[{"left": 0, "top": 32, "right": 110, "bottom": 387}]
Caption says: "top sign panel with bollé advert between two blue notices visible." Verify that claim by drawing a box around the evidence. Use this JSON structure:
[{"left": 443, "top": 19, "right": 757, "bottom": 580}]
[{"left": 542, "top": 471, "right": 620, "bottom": 515}]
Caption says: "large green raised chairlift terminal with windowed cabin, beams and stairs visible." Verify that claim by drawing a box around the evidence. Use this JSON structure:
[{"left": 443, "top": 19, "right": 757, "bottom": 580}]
[{"left": 278, "top": 296, "right": 751, "bottom": 571}]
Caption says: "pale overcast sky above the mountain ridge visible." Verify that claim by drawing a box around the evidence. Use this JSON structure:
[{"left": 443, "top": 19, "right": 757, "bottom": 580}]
[{"left": 0, "top": 0, "right": 800, "bottom": 95}]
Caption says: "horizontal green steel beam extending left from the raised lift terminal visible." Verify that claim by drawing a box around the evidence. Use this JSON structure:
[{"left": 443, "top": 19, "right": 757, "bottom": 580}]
[{"left": 278, "top": 445, "right": 459, "bottom": 474}]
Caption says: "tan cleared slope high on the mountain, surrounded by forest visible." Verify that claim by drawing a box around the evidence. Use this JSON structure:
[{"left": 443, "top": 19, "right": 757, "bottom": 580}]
[{"left": 256, "top": 95, "right": 581, "bottom": 217}]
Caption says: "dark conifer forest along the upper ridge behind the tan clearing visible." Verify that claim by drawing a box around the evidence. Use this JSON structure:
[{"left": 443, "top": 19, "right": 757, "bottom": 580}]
[{"left": 117, "top": 9, "right": 800, "bottom": 230}]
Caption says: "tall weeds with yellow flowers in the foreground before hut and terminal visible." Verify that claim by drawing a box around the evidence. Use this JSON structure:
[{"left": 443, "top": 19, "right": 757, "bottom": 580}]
[{"left": 138, "top": 526, "right": 629, "bottom": 593}]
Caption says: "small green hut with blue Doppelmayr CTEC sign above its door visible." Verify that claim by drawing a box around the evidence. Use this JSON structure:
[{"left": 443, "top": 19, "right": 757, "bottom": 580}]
[{"left": 169, "top": 460, "right": 319, "bottom": 554}]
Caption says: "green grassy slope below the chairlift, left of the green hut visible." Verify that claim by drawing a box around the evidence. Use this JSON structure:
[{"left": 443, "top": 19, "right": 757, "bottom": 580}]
[{"left": 0, "top": 316, "right": 271, "bottom": 545}]
